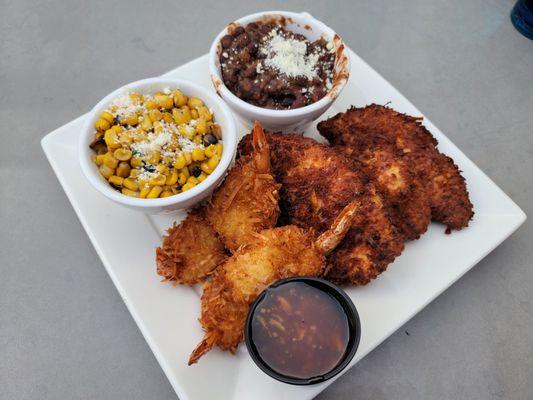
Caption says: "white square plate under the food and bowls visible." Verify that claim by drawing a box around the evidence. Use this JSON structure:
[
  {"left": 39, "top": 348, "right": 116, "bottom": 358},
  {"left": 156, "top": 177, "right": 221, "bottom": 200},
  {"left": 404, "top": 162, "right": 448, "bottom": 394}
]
[{"left": 42, "top": 47, "right": 526, "bottom": 400}]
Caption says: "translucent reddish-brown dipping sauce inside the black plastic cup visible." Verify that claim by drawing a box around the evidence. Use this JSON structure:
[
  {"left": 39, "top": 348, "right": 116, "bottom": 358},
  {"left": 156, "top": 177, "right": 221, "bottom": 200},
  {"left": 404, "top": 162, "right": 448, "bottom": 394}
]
[{"left": 251, "top": 281, "right": 350, "bottom": 379}]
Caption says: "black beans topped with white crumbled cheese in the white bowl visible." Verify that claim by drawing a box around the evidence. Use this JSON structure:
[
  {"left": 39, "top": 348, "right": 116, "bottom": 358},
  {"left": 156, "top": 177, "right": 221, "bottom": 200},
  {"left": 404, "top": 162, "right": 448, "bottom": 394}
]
[{"left": 219, "top": 22, "right": 335, "bottom": 110}]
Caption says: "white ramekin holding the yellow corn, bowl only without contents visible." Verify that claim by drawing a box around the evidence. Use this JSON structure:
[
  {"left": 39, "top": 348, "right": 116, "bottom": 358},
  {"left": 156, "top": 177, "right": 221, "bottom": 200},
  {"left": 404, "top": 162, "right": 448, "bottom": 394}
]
[{"left": 78, "top": 78, "right": 237, "bottom": 214}]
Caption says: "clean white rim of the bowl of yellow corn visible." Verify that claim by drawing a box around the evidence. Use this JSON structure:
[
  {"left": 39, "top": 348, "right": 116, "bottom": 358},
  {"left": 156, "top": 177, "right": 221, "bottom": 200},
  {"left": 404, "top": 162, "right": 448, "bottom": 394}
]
[{"left": 78, "top": 77, "right": 237, "bottom": 209}]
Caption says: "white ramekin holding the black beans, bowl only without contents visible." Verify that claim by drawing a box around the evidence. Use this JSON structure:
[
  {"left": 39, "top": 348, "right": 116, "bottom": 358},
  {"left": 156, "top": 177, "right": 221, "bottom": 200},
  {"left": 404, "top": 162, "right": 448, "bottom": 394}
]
[{"left": 209, "top": 11, "right": 350, "bottom": 131}]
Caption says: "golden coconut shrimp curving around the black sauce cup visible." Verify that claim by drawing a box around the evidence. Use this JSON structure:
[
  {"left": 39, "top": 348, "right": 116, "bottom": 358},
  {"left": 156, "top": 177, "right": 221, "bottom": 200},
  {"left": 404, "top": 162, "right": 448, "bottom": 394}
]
[{"left": 189, "top": 202, "right": 359, "bottom": 365}]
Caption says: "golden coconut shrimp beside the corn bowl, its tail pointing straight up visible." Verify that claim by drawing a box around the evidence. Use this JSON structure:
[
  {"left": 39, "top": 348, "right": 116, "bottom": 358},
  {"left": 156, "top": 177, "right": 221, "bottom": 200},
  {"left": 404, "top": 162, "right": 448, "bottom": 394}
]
[{"left": 206, "top": 122, "right": 280, "bottom": 253}]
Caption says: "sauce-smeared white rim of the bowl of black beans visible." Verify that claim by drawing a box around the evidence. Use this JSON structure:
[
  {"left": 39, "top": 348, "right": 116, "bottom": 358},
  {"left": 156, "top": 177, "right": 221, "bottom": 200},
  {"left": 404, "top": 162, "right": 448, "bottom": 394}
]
[{"left": 208, "top": 11, "right": 350, "bottom": 118}]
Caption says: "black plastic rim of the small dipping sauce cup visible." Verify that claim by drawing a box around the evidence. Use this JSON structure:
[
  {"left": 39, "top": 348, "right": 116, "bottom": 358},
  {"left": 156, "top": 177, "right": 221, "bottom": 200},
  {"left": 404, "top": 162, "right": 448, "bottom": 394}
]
[{"left": 244, "top": 276, "right": 361, "bottom": 386}]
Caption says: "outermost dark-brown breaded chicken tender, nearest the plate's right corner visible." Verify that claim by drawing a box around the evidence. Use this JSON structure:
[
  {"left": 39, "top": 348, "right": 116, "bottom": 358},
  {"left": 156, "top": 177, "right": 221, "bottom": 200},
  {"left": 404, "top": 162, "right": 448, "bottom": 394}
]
[{"left": 319, "top": 104, "right": 474, "bottom": 229}]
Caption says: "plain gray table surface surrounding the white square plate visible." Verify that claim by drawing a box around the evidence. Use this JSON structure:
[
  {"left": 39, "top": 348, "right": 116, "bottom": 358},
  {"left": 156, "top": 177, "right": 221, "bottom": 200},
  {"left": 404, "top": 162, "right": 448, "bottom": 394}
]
[{"left": 0, "top": 0, "right": 533, "bottom": 400}]
